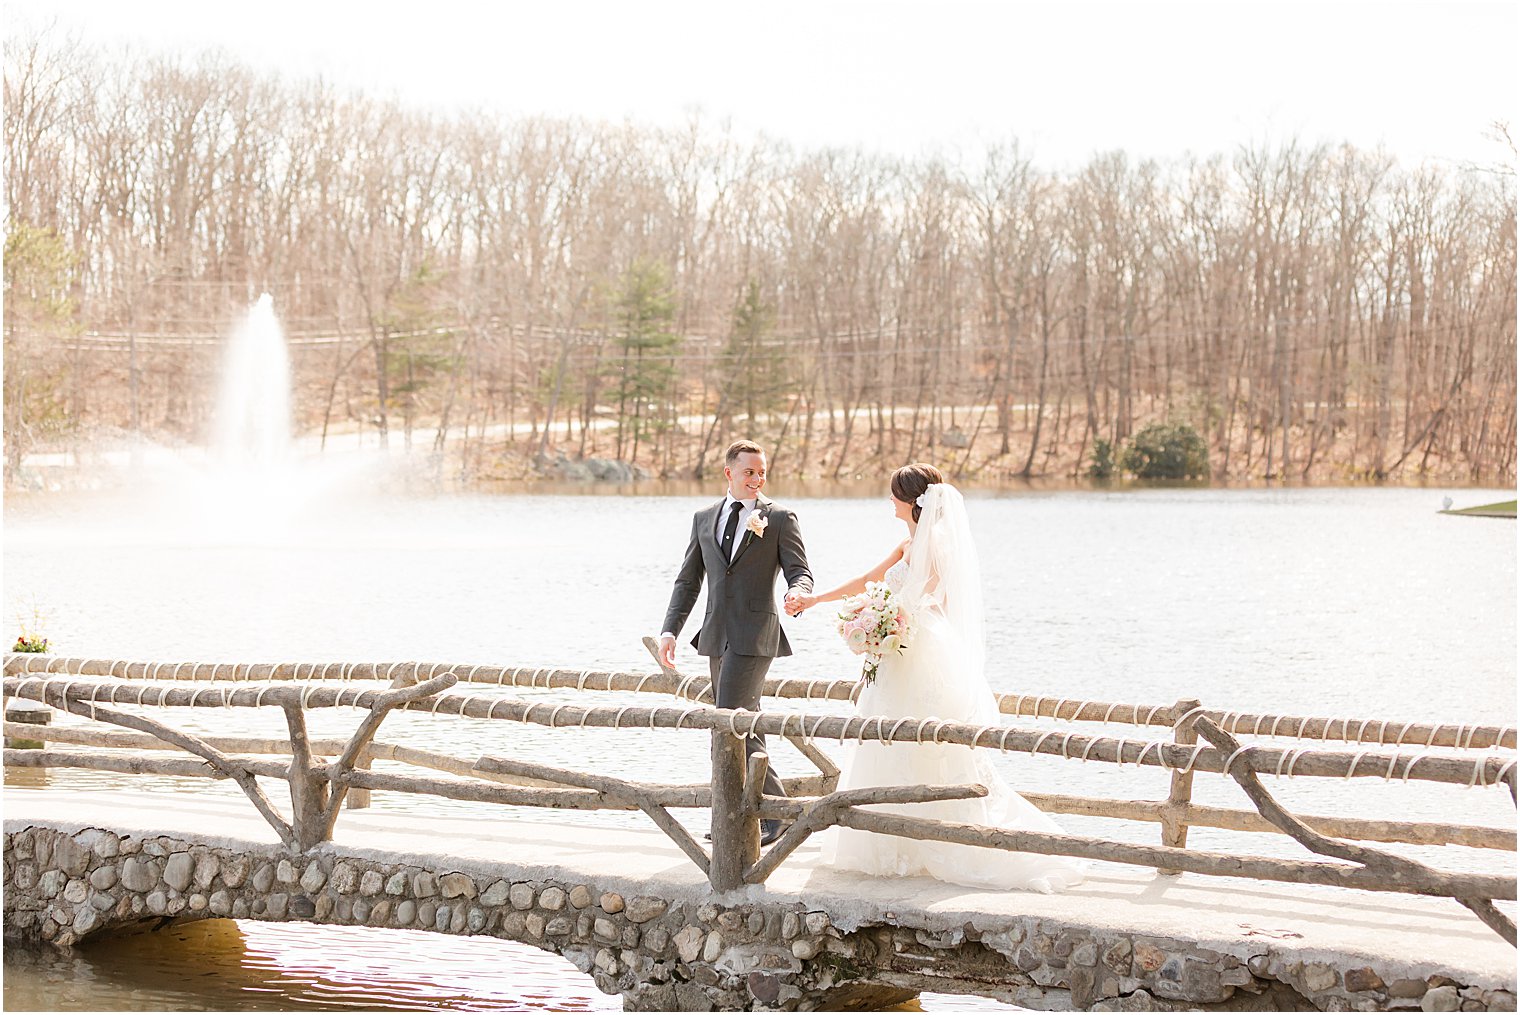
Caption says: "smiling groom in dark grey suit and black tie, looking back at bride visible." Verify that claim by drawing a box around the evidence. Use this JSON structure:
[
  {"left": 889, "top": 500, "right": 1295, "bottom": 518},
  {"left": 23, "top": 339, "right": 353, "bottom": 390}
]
[{"left": 660, "top": 441, "right": 813, "bottom": 845}]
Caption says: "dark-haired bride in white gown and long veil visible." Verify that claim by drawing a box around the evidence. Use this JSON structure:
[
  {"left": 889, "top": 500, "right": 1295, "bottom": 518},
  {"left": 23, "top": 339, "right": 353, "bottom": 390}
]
[{"left": 790, "top": 465, "right": 1082, "bottom": 892}]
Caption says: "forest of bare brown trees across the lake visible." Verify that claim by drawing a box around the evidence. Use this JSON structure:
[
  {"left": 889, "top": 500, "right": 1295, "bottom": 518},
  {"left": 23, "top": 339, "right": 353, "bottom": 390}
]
[{"left": 5, "top": 32, "right": 1515, "bottom": 485}]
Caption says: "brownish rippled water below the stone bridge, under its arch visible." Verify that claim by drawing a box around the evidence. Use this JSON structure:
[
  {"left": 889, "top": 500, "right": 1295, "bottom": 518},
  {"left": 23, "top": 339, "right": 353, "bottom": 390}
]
[{"left": 5, "top": 919, "right": 1018, "bottom": 1012}]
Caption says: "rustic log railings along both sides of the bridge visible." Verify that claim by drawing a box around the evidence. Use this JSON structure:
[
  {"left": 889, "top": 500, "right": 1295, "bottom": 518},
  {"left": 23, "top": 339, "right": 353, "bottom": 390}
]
[{"left": 5, "top": 655, "right": 1515, "bottom": 944}]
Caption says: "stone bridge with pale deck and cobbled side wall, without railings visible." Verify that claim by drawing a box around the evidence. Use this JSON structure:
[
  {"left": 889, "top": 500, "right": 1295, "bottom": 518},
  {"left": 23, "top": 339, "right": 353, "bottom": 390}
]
[{"left": 5, "top": 787, "right": 1515, "bottom": 1010}]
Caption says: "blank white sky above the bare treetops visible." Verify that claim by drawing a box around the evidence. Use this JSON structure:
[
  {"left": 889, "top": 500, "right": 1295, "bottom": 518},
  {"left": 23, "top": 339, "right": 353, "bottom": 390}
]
[{"left": 6, "top": 0, "right": 1520, "bottom": 169}]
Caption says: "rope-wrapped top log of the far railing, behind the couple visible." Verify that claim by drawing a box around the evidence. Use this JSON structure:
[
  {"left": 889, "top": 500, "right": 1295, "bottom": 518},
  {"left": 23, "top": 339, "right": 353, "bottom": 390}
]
[{"left": 5, "top": 650, "right": 1515, "bottom": 751}]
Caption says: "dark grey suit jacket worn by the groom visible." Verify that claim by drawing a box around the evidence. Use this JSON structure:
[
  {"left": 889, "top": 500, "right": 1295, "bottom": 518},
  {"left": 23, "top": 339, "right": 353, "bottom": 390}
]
[{"left": 661, "top": 497, "right": 813, "bottom": 656}]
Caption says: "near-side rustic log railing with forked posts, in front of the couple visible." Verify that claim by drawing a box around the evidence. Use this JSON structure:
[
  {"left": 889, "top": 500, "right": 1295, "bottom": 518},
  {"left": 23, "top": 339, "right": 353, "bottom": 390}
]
[{"left": 5, "top": 673, "right": 1515, "bottom": 941}]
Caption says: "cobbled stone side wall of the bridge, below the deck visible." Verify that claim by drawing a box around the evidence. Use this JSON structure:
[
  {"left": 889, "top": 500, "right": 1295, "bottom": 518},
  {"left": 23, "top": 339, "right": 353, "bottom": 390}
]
[{"left": 5, "top": 825, "right": 1515, "bottom": 1010}]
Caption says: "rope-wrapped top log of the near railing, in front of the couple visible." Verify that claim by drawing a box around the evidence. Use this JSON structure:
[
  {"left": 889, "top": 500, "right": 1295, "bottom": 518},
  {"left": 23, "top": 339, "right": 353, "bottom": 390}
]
[{"left": 5, "top": 678, "right": 1515, "bottom": 787}]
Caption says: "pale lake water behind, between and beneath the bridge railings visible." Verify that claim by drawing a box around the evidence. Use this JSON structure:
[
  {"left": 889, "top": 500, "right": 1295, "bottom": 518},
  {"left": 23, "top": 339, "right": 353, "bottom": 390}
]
[{"left": 5, "top": 480, "right": 1515, "bottom": 1010}]
